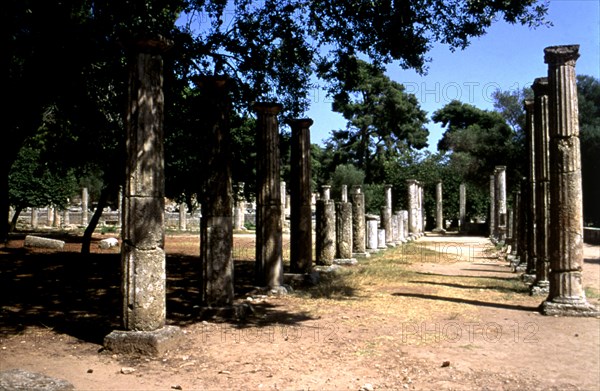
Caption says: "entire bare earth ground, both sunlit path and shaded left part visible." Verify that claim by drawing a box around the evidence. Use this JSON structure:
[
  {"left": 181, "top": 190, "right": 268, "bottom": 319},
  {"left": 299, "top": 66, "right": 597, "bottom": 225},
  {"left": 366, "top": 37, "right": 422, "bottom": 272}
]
[{"left": 0, "top": 235, "right": 600, "bottom": 390}]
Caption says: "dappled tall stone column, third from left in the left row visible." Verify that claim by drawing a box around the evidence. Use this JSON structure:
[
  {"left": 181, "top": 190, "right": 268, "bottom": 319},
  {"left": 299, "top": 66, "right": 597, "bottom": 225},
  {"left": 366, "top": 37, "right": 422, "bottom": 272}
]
[{"left": 254, "top": 103, "right": 283, "bottom": 289}]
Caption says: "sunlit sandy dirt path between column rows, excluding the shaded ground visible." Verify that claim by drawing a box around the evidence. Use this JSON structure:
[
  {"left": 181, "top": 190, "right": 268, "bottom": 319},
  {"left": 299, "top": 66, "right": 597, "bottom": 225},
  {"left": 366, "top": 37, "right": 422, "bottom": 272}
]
[{"left": 0, "top": 236, "right": 600, "bottom": 391}]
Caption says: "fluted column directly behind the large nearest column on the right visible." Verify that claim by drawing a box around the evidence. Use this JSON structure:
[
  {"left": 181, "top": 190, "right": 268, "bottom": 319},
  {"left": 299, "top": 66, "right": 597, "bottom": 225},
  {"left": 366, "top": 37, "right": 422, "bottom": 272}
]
[{"left": 531, "top": 77, "right": 550, "bottom": 295}]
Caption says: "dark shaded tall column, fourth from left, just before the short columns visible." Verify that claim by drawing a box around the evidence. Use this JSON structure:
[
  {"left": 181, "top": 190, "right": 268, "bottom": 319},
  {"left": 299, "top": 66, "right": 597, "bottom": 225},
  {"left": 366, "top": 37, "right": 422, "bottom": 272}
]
[{"left": 289, "top": 118, "right": 314, "bottom": 273}]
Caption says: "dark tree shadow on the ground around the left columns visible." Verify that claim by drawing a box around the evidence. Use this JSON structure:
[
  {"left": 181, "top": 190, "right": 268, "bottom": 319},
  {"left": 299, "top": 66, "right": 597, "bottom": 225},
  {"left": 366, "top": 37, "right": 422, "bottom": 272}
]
[{"left": 0, "top": 237, "right": 310, "bottom": 344}]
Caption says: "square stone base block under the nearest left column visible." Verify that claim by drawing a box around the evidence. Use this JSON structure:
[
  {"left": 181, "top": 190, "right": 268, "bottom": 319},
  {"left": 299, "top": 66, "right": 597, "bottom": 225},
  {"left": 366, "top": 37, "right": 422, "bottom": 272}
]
[{"left": 104, "top": 326, "right": 183, "bottom": 356}]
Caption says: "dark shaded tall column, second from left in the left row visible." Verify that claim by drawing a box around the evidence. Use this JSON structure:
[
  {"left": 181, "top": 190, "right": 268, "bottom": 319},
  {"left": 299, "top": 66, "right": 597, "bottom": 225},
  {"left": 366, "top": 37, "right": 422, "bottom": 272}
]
[{"left": 198, "top": 76, "right": 233, "bottom": 306}]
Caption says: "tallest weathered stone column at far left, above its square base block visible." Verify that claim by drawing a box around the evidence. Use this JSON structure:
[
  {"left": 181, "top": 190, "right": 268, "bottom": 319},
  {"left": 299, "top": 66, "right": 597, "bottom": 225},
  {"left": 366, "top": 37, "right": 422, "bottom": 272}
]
[{"left": 121, "top": 39, "right": 169, "bottom": 331}]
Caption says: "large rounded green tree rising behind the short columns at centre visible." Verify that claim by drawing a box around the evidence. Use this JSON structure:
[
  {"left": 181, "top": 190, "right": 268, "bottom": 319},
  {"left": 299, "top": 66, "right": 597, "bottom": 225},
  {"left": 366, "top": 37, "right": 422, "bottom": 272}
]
[{"left": 325, "top": 60, "right": 429, "bottom": 182}]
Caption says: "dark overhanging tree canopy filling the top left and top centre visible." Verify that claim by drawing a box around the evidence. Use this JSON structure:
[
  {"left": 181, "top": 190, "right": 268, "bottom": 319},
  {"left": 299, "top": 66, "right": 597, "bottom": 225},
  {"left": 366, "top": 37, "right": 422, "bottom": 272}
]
[{"left": 0, "top": 0, "right": 547, "bottom": 240}]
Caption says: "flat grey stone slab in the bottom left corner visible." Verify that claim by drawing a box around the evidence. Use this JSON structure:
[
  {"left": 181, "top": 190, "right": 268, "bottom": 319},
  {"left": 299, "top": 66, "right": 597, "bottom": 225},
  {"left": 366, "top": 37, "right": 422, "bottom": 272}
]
[{"left": 0, "top": 369, "right": 75, "bottom": 391}]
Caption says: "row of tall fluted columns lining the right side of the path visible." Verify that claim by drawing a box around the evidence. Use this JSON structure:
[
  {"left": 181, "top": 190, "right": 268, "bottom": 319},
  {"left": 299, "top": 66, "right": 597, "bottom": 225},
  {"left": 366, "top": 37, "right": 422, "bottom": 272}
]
[{"left": 496, "top": 45, "right": 600, "bottom": 316}]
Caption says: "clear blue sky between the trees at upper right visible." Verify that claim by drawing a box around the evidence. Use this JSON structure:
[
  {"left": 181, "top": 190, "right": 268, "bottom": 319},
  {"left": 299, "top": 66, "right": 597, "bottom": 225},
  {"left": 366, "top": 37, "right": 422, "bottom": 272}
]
[{"left": 306, "top": 0, "right": 600, "bottom": 151}]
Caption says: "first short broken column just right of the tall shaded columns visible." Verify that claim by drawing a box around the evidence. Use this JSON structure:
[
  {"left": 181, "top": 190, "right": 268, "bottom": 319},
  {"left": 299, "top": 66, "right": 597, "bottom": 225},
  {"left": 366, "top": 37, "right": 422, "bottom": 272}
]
[{"left": 315, "top": 185, "right": 336, "bottom": 265}]
